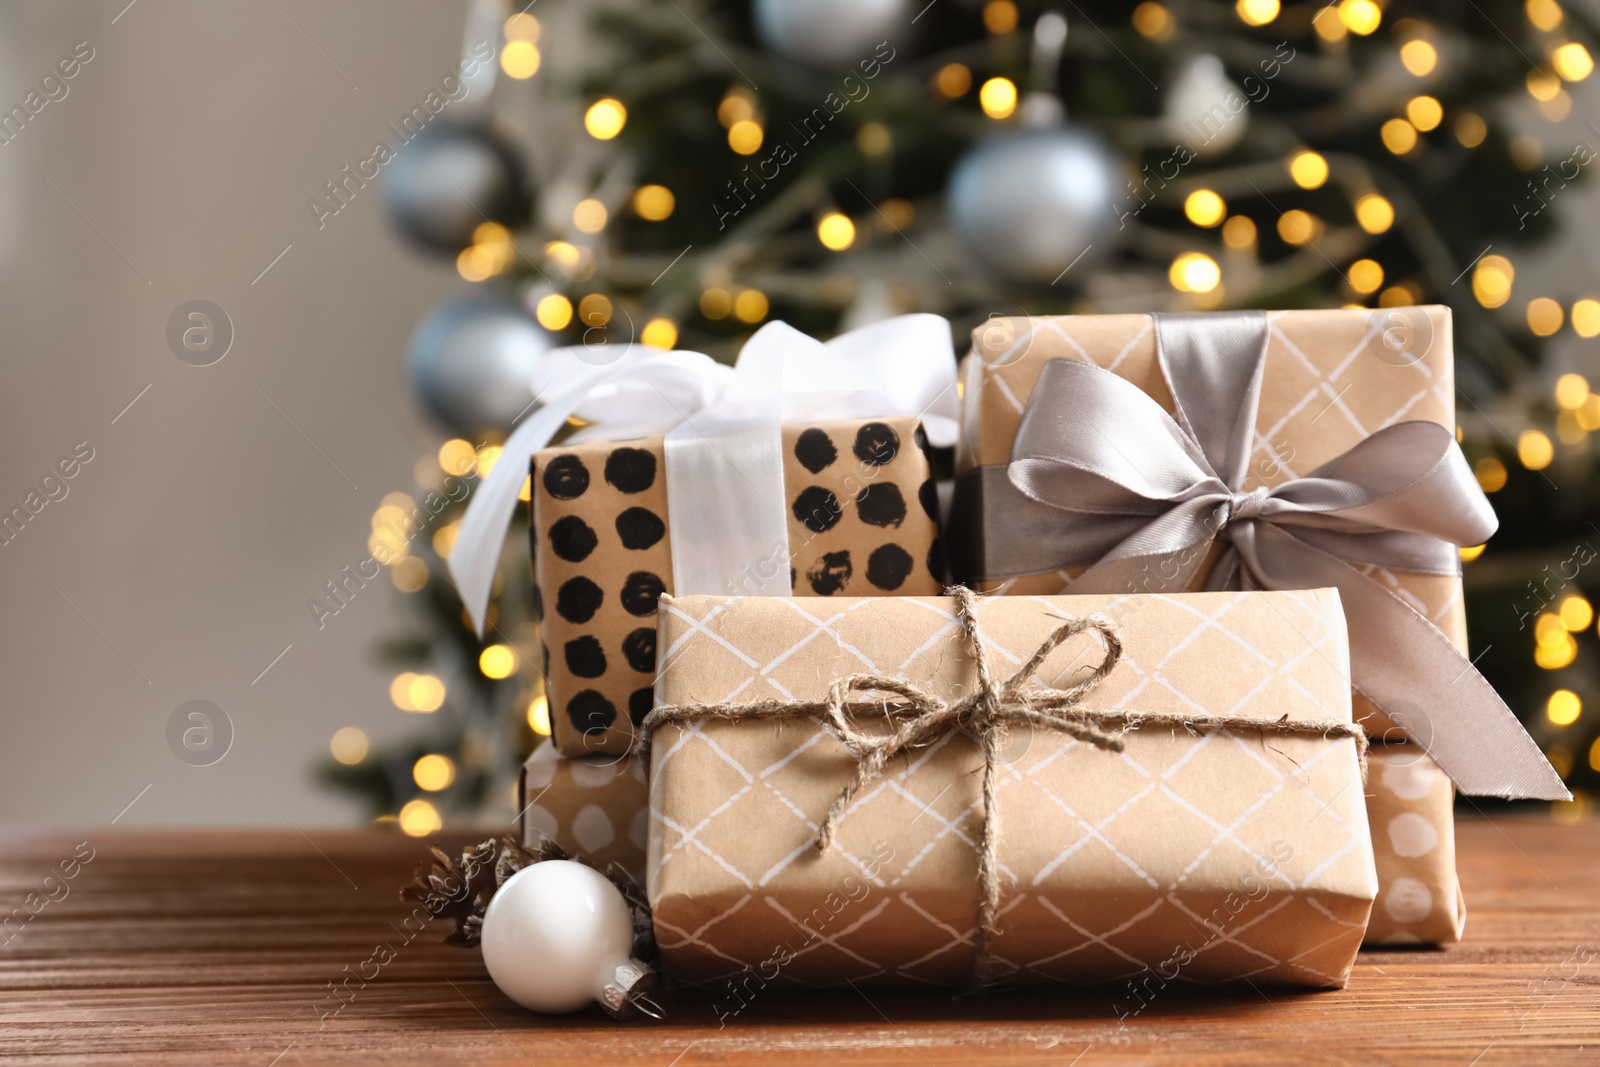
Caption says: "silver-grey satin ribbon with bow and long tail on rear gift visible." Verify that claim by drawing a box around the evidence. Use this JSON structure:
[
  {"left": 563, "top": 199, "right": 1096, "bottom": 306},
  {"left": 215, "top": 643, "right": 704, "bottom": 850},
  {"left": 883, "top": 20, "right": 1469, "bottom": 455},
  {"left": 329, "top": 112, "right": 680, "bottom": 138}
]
[{"left": 982, "top": 312, "right": 1570, "bottom": 800}]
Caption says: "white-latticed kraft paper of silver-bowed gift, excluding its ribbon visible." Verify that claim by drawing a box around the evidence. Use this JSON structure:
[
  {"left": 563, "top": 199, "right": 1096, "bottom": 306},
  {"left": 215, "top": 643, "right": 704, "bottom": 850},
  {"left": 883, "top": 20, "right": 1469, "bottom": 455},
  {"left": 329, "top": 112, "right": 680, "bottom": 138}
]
[{"left": 950, "top": 307, "right": 1467, "bottom": 737}]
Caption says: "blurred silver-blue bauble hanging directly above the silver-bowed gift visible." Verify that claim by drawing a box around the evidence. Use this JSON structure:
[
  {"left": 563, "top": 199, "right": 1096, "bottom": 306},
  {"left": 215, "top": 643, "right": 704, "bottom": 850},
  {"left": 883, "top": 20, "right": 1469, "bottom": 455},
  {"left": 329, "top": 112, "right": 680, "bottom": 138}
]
[{"left": 949, "top": 125, "right": 1120, "bottom": 283}]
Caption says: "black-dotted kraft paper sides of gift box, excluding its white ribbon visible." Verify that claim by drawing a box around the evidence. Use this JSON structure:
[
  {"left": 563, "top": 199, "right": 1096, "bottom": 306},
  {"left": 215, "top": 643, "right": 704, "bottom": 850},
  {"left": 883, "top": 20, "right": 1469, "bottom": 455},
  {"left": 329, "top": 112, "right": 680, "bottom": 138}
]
[{"left": 528, "top": 418, "right": 944, "bottom": 755}]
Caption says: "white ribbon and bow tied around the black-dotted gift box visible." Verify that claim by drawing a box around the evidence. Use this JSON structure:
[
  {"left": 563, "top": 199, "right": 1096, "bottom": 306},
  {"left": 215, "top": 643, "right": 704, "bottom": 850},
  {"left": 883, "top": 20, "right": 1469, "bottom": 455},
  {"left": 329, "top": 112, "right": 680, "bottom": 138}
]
[{"left": 450, "top": 315, "right": 958, "bottom": 635}]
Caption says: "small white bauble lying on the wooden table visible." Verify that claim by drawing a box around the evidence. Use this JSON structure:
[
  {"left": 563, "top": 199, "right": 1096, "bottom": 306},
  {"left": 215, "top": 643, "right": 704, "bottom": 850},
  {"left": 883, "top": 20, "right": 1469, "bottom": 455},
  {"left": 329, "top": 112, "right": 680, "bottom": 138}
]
[{"left": 483, "top": 859, "right": 653, "bottom": 1014}]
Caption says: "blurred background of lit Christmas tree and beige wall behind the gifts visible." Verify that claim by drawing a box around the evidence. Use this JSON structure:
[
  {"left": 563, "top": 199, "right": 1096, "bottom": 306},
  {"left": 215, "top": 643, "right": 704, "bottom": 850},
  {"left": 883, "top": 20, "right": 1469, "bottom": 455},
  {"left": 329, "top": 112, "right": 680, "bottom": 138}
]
[{"left": 0, "top": 0, "right": 1600, "bottom": 833}]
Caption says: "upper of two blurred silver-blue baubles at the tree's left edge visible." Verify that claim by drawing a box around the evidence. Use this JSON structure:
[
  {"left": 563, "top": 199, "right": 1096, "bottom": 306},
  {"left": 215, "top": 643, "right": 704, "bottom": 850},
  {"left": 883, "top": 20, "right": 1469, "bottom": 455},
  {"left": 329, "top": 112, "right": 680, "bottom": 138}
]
[{"left": 382, "top": 123, "right": 528, "bottom": 256}]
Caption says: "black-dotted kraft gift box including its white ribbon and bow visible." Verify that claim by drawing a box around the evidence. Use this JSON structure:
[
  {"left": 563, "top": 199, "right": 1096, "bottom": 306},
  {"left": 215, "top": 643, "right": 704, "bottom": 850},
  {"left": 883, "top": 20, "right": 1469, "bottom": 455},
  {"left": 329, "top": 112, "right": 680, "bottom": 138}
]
[{"left": 450, "top": 315, "right": 960, "bottom": 755}]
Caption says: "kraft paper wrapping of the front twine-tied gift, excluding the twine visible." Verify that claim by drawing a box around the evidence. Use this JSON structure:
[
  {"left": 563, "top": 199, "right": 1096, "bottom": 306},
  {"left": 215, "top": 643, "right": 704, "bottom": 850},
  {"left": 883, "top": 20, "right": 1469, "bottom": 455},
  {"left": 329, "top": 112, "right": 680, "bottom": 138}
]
[{"left": 648, "top": 590, "right": 1378, "bottom": 987}]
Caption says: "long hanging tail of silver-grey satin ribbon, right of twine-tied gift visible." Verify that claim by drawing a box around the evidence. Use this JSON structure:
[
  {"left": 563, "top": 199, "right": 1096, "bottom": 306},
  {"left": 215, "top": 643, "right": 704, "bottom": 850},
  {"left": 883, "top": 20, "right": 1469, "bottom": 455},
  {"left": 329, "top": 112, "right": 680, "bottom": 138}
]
[{"left": 1238, "top": 523, "right": 1571, "bottom": 800}]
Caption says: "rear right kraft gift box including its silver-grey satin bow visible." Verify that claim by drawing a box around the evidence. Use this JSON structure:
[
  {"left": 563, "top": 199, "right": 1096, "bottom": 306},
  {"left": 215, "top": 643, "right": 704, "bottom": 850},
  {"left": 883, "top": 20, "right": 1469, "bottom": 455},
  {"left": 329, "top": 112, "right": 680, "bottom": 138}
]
[{"left": 947, "top": 307, "right": 1566, "bottom": 798}]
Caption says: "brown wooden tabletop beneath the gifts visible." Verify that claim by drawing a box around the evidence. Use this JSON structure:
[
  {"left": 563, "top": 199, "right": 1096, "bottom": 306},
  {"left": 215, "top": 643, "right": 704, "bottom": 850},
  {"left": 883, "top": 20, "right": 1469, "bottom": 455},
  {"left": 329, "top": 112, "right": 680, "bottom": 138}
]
[{"left": 0, "top": 817, "right": 1600, "bottom": 1067}]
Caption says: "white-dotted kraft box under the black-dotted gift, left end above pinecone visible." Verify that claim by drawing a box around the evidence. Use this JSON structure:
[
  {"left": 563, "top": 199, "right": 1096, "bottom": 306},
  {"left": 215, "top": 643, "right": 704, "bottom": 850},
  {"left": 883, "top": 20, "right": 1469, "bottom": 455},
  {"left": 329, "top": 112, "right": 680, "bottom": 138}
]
[{"left": 517, "top": 742, "right": 650, "bottom": 885}]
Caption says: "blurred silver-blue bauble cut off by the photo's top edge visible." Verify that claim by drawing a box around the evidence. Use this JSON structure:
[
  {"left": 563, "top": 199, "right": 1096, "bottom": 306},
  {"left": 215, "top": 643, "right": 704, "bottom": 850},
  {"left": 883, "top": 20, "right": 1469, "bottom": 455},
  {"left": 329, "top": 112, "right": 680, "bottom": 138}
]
[{"left": 755, "top": 0, "right": 915, "bottom": 67}]
